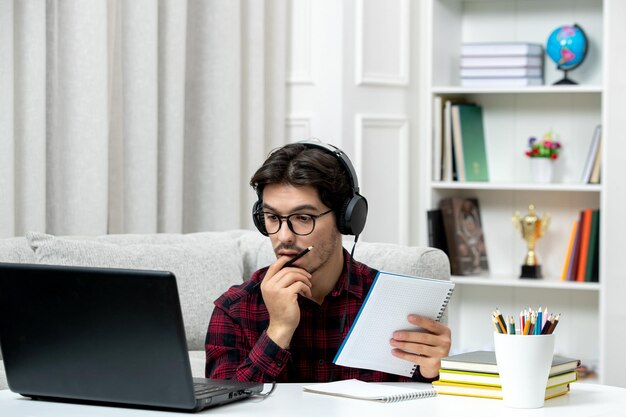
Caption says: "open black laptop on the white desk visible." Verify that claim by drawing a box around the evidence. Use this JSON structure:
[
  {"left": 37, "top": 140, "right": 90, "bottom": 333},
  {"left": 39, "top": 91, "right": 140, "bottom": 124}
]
[{"left": 0, "top": 263, "right": 263, "bottom": 411}]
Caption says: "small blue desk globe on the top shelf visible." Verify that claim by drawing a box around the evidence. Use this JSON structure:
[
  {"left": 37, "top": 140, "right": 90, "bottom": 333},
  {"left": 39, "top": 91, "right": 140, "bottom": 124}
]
[{"left": 546, "top": 24, "right": 589, "bottom": 85}]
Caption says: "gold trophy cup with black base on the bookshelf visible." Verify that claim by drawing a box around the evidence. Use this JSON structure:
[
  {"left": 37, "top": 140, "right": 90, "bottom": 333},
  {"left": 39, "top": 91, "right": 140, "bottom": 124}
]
[{"left": 513, "top": 204, "right": 550, "bottom": 278}]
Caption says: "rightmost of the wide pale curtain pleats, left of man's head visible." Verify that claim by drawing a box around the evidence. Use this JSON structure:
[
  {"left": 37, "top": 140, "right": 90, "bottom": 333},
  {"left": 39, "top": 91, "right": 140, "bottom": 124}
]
[{"left": 183, "top": 0, "right": 242, "bottom": 232}]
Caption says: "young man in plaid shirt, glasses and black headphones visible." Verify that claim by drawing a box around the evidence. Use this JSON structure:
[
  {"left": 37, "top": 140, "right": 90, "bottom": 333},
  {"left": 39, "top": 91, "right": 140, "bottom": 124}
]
[{"left": 205, "top": 143, "right": 450, "bottom": 382}]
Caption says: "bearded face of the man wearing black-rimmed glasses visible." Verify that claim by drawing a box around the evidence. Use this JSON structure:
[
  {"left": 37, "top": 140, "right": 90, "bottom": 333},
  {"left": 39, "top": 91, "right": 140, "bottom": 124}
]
[{"left": 263, "top": 184, "right": 343, "bottom": 274}]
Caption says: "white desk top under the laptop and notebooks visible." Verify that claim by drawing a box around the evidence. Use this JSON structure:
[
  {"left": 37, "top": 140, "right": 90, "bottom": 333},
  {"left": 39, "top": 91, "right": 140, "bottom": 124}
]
[{"left": 0, "top": 382, "right": 626, "bottom": 417}]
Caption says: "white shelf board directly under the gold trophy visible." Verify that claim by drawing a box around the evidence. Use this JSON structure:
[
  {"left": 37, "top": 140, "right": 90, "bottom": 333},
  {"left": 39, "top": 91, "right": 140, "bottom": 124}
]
[{"left": 450, "top": 276, "right": 600, "bottom": 291}]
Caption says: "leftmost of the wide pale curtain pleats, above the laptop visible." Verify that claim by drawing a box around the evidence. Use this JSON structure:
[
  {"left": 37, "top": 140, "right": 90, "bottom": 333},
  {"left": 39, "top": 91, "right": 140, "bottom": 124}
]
[{"left": 47, "top": 0, "right": 109, "bottom": 234}]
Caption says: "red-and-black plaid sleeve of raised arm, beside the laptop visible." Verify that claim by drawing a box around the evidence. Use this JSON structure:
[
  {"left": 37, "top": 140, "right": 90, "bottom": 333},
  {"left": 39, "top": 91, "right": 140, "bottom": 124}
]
[{"left": 205, "top": 305, "right": 291, "bottom": 382}]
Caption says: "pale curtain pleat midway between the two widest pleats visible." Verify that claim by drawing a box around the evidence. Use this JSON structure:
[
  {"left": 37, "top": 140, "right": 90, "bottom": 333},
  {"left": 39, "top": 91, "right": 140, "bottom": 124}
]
[{"left": 122, "top": 0, "right": 159, "bottom": 233}]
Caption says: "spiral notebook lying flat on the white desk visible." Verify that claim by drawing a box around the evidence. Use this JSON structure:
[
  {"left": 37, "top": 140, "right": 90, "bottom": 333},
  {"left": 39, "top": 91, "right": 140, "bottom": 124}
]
[{"left": 302, "top": 379, "right": 437, "bottom": 403}]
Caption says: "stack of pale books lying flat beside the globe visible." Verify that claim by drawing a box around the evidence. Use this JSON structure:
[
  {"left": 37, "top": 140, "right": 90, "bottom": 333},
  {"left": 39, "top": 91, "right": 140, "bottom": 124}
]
[{"left": 461, "top": 42, "right": 543, "bottom": 87}]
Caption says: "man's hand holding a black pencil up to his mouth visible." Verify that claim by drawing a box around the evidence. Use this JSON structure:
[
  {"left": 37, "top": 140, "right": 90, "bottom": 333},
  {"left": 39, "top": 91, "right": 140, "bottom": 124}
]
[{"left": 261, "top": 256, "right": 312, "bottom": 349}]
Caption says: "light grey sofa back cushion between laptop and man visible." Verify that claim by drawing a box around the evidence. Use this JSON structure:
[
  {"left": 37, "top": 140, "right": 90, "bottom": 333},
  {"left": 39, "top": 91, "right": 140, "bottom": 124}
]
[{"left": 26, "top": 232, "right": 243, "bottom": 350}]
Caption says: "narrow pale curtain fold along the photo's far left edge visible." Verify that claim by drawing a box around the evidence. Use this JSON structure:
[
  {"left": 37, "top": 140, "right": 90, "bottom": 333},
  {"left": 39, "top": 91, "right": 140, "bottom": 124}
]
[{"left": 0, "top": 0, "right": 16, "bottom": 237}]
